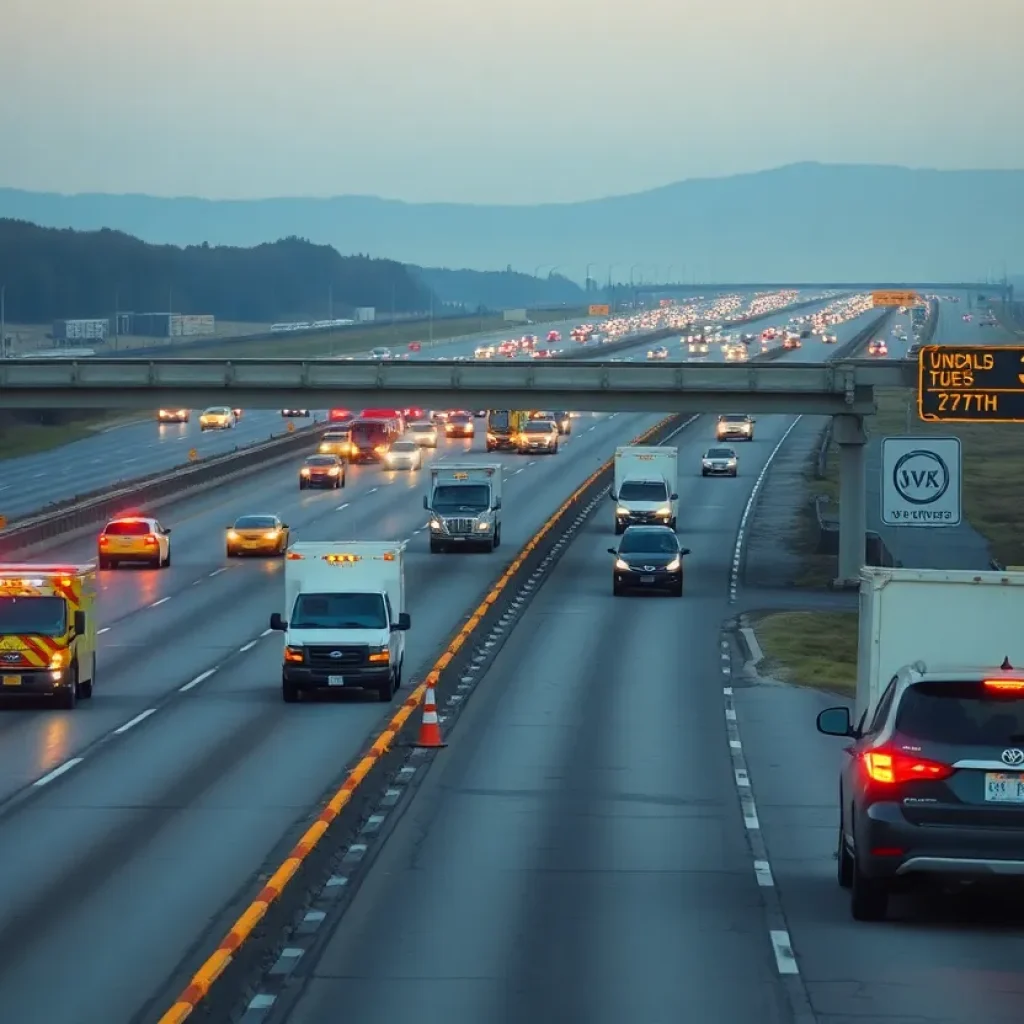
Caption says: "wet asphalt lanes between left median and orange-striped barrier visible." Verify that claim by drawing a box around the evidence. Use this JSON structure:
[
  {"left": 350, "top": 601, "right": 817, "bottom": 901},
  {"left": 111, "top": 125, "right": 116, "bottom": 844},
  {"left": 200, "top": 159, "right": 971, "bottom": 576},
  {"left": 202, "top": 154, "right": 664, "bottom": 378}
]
[{"left": 0, "top": 288, "right": 864, "bottom": 1024}]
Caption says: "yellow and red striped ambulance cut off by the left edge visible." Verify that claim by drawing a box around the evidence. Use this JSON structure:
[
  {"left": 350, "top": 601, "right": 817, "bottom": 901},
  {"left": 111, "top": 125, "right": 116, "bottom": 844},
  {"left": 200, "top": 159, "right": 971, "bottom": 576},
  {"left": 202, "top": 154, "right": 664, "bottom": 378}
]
[{"left": 0, "top": 562, "right": 96, "bottom": 711}]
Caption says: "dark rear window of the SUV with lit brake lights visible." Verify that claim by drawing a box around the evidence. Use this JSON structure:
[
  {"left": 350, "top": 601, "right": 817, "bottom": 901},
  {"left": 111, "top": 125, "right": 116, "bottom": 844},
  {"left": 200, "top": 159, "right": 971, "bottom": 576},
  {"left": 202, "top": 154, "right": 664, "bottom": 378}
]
[{"left": 896, "top": 681, "right": 1024, "bottom": 748}]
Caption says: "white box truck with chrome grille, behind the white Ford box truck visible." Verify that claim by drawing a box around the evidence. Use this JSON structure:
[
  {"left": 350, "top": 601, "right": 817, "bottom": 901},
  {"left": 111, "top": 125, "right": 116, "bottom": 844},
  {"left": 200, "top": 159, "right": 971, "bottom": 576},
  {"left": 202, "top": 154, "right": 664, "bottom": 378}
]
[{"left": 423, "top": 462, "right": 502, "bottom": 554}]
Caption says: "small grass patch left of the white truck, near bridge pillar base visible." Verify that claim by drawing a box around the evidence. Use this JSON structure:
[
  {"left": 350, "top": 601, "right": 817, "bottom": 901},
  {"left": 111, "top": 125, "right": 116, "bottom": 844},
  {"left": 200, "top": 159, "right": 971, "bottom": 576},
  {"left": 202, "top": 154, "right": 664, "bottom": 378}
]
[{"left": 752, "top": 611, "right": 857, "bottom": 695}]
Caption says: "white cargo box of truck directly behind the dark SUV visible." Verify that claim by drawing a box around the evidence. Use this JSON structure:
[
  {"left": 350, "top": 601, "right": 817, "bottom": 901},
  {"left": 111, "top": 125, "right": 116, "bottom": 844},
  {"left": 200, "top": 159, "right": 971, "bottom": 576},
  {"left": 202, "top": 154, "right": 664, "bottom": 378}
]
[{"left": 853, "top": 566, "right": 1024, "bottom": 725}]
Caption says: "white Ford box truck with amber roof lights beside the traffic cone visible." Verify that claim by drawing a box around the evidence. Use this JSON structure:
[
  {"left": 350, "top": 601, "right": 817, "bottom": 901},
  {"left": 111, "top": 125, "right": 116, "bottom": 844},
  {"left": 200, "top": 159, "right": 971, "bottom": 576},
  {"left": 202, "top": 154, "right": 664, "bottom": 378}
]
[{"left": 270, "top": 541, "right": 410, "bottom": 703}]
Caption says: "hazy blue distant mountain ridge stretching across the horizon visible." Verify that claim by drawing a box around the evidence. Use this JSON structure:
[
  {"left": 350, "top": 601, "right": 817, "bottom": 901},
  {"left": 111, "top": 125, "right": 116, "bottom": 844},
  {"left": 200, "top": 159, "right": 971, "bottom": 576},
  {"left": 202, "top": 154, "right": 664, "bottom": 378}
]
[{"left": 0, "top": 161, "right": 1024, "bottom": 283}]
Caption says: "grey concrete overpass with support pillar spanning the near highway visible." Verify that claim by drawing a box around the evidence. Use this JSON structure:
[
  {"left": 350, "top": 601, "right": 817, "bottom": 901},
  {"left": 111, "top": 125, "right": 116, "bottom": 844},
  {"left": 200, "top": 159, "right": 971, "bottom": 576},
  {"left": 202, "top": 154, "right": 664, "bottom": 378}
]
[{"left": 0, "top": 358, "right": 918, "bottom": 581}]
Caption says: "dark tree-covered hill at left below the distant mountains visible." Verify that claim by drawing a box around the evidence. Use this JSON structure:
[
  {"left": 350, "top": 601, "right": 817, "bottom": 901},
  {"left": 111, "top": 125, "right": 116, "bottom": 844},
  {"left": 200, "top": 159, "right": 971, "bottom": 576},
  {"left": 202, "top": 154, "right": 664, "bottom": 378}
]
[{"left": 0, "top": 219, "right": 431, "bottom": 324}]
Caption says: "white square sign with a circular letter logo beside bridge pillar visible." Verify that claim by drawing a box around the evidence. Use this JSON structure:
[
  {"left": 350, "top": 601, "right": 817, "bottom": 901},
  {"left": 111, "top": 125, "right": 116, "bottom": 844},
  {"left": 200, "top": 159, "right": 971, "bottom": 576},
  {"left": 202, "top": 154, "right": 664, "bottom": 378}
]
[{"left": 880, "top": 437, "right": 963, "bottom": 526}]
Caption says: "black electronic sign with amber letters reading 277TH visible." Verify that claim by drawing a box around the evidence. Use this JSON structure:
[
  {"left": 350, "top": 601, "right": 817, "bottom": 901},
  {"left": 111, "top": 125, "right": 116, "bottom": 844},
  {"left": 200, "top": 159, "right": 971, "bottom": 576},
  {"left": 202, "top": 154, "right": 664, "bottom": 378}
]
[{"left": 918, "top": 345, "right": 1024, "bottom": 423}]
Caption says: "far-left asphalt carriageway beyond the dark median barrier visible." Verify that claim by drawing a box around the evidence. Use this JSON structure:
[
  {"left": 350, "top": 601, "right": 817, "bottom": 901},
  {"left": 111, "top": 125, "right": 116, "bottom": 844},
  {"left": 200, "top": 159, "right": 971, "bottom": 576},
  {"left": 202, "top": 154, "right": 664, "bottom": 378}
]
[{"left": 0, "top": 294, "right": 765, "bottom": 519}]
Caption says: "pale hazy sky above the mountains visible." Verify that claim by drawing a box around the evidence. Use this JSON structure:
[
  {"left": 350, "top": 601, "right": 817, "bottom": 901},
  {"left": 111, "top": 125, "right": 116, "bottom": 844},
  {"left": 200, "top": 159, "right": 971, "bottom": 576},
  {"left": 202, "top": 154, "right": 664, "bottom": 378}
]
[{"left": 0, "top": 0, "right": 1024, "bottom": 203}]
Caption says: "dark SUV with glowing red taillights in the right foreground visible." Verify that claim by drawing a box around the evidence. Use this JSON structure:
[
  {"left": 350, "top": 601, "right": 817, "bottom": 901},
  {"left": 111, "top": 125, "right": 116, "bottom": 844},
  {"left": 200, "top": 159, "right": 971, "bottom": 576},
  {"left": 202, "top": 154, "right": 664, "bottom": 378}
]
[{"left": 817, "top": 659, "right": 1024, "bottom": 921}]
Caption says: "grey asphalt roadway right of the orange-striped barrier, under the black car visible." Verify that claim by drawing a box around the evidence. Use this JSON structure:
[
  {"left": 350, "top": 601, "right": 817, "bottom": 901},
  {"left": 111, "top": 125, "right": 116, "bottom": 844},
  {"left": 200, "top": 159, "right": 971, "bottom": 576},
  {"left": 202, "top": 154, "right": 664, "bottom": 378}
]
[{"left": 268, "top": 405, "right": 830, "bottom": 1024}]
